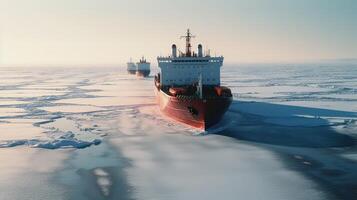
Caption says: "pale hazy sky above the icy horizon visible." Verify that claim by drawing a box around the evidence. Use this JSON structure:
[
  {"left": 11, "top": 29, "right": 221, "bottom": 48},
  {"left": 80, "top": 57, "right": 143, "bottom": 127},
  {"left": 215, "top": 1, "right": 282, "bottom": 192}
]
[{"left": 0, "top": 0, "right": 357, "bottom": 65}]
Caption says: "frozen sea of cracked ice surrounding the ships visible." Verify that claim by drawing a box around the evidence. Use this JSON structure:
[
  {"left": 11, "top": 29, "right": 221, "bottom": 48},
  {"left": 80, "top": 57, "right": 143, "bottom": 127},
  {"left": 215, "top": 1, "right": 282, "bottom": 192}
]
[{"left": 0, "top": 64, "right": 357, "bottom": 200}]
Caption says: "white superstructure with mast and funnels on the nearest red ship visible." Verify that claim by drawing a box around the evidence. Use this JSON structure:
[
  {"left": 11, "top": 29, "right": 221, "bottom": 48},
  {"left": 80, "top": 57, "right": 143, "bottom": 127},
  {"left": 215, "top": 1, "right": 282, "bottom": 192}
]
[{"left": 157, "top": 30, "right": 223, "bottom": 86}]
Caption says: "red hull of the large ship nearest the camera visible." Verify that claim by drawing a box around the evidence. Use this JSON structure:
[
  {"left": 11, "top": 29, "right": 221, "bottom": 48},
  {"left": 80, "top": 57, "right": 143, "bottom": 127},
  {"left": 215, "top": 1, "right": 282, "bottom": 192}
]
[{"left": 155, "top": 88, "right": 232, "bottom": 130}]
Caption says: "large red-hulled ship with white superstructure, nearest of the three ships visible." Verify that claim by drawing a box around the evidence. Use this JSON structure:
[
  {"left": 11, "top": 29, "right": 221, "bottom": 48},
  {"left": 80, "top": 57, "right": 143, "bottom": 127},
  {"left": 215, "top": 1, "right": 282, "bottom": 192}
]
[{"left": 155, "top": 29, "right": 233, "bottom": 130}]
